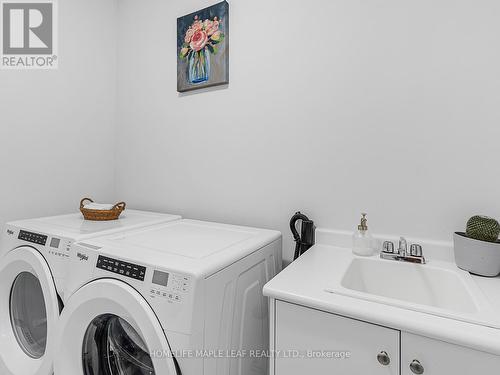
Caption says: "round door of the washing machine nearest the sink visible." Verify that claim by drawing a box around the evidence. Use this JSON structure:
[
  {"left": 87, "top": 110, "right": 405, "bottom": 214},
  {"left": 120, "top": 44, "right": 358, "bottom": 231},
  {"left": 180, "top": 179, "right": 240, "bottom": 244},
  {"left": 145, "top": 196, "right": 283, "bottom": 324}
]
[{"left": 54, "top": 279, "right": 177, "bottom": 375}]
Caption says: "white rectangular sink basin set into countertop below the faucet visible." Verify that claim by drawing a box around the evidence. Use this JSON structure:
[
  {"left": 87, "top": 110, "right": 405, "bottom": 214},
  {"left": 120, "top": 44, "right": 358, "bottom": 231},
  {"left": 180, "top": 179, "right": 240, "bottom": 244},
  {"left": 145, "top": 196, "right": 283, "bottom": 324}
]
[{"left": 326, "top": 257, "right": 500, "bottom": 328}]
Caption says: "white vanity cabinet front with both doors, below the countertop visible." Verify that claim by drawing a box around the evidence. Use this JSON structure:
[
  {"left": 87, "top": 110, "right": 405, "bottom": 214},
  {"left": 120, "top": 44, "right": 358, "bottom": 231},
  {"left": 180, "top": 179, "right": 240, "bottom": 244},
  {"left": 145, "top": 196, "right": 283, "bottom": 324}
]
[{"left": 270, "top": 300, "right": 500, "bottom": 375}]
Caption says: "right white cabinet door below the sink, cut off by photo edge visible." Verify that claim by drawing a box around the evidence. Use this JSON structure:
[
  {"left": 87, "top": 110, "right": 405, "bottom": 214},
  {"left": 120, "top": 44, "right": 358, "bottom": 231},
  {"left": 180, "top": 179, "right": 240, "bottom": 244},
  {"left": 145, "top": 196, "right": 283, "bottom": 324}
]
[{"left": 401, "top": 332, "right": 500, "bottom": 375}]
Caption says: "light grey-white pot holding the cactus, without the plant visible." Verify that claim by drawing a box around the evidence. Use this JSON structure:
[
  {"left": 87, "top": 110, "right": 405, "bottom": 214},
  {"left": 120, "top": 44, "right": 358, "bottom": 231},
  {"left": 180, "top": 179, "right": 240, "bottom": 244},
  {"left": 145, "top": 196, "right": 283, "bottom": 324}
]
[{"left": 453, "top": 232, "right": 500, "bottom": 277}]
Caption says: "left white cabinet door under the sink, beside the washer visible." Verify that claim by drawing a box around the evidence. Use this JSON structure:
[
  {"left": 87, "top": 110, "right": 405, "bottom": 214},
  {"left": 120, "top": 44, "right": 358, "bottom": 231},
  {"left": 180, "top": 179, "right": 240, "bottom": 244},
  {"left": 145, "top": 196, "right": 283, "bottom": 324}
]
[{"left": 274, "top": 301, "right": 399, "bottom": 375}]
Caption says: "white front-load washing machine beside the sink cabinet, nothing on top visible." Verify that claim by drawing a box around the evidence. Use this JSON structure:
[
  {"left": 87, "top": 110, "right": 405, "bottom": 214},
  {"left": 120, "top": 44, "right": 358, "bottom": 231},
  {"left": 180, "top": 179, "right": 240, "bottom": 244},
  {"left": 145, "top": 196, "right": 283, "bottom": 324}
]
[{"left": 54, "top": 220, "right": 282, "bottom": 375}]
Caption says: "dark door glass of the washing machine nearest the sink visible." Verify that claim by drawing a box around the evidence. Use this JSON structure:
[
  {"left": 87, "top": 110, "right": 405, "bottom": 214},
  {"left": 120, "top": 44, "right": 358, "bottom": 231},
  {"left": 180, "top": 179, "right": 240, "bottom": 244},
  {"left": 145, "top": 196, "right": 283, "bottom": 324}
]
[{"left": 82, "top": 314, "right": 155, "bottom": 375}]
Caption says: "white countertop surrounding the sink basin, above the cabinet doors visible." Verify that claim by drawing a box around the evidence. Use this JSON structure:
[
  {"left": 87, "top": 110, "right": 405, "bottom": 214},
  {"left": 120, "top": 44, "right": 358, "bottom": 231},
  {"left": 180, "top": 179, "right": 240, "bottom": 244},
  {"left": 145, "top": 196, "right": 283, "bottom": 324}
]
[{"left": 264, "top": 231, "right": 500, "bottom": 355}]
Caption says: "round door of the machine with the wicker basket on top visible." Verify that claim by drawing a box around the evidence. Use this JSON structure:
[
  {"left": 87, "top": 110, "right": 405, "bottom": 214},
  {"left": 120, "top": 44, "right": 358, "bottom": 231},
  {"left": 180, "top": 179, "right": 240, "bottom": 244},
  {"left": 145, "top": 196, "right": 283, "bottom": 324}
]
[{"left": 0, "top": 247, "right": 59, "bottom": 375}]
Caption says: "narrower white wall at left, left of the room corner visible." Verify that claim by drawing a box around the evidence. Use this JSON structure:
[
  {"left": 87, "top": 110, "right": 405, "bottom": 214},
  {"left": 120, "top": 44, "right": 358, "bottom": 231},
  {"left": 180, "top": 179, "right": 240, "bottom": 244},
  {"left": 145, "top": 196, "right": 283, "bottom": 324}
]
[{"left": 0, "top": 0, "right": 116, "bottom": 224}]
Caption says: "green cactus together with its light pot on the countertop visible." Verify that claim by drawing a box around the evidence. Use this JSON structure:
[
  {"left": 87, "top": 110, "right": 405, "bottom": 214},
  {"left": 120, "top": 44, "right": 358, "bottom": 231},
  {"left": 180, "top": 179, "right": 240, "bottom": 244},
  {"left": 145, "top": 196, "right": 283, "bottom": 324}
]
[{"left": 454, "top": 216, "right": 500, "bottom": 277}]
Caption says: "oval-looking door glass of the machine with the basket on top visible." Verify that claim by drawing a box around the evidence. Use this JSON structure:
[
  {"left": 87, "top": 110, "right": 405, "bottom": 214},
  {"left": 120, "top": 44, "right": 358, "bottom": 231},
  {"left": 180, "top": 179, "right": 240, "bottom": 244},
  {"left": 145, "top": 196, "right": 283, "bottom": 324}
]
[{"left": 10, "top": 272, "right": 47, "bottom": 359}]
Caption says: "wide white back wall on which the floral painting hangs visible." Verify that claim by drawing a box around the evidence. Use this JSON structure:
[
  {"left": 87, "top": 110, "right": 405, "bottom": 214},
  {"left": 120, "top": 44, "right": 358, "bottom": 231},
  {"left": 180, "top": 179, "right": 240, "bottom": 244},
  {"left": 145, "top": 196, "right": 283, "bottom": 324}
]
[{"left": 114, "top": 0, "right": 500, "bottom": 257}]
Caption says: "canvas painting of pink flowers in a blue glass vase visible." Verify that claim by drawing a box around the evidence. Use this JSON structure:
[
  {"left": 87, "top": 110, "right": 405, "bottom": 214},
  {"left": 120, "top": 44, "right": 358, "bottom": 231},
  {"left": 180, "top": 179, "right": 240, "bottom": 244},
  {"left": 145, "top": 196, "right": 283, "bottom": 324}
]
[{"left": 177, "top": 1, "right": 229, "bottom": 92}]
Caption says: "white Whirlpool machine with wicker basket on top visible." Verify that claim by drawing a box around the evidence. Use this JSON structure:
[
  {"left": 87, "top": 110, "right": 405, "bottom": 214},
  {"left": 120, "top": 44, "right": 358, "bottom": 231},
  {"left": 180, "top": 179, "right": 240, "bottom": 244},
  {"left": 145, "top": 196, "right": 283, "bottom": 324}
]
[{"left": 0, "top": 210, "right": 180, "bottom": 375}]
